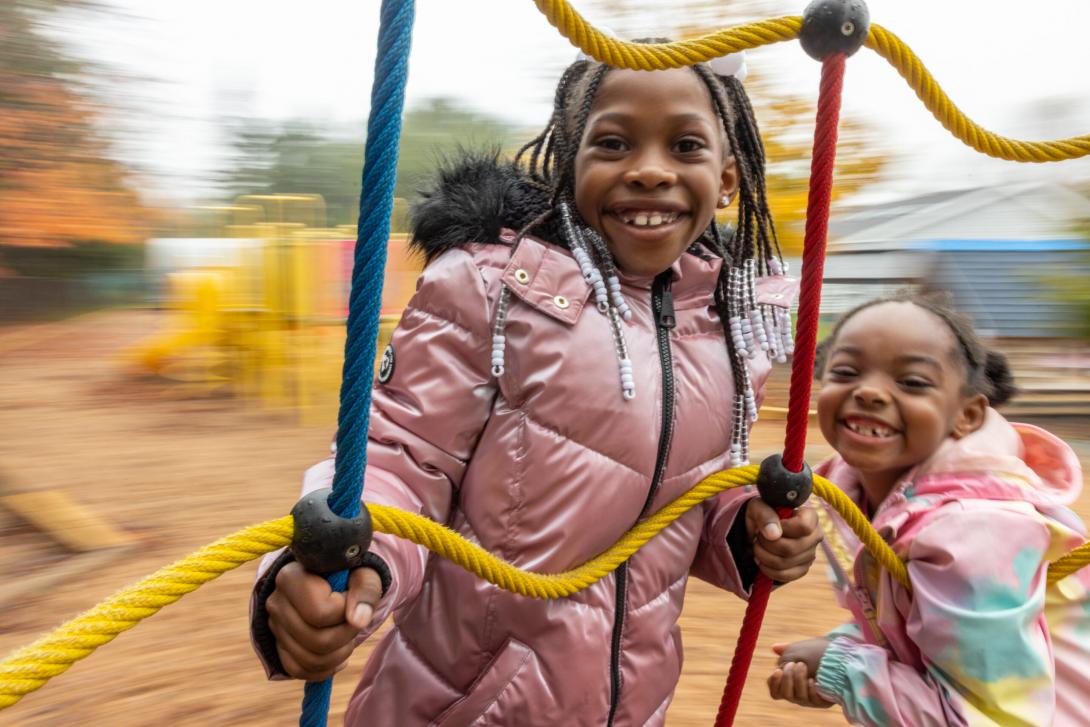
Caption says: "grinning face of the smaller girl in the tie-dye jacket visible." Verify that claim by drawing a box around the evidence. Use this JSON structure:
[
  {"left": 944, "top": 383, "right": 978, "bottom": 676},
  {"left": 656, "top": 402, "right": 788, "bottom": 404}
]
[{"left": 818, "top": 302, "right": 988, "bottom": 492}]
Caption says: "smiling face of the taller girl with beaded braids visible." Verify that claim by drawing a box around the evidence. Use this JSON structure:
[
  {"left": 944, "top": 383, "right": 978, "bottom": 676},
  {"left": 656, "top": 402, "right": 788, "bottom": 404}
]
[{"left": 576, "top": 69, "right": 738, "bottom": 276}]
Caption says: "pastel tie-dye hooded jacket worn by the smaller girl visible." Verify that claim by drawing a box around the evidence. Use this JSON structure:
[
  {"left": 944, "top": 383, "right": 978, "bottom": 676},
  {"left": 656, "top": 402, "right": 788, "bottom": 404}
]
[{"left": 816, "top": 410, "right": 1090, "bottom": 727}]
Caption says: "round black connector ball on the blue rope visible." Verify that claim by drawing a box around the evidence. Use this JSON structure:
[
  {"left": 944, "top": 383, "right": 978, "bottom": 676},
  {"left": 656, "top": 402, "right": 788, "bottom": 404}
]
[{"left": 291, "top": 487, "right": 373, "bottom": 575}]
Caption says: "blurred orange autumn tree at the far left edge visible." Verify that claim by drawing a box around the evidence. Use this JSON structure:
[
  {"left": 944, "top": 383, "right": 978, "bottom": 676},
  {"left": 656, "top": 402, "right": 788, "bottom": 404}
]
[{"left": 0, "top": 0, "right": 145, "bottom": 246}]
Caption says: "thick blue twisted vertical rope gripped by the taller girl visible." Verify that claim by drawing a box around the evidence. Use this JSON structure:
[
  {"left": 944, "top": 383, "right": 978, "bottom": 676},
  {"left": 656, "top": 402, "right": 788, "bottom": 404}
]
[{"left": 299, "top": 0, "right": 414, "bottom": 727}]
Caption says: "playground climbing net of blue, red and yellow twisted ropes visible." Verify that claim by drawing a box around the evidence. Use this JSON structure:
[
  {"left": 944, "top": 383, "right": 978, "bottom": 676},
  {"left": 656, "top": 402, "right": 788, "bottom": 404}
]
[{"left": 0, "top": 0, "right": 1090, "bottom": 727}]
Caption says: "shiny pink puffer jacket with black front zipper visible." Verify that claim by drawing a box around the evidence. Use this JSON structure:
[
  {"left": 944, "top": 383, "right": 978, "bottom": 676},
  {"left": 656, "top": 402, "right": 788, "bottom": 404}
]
[{"left": 249, "top": 156, "right": 786, "bottom": 727}]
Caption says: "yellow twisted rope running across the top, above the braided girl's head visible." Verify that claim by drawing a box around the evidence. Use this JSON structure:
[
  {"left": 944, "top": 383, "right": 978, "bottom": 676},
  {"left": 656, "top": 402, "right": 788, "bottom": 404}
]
[{"left": 534, "top": 0, "right": 1090, "bottom": 161}]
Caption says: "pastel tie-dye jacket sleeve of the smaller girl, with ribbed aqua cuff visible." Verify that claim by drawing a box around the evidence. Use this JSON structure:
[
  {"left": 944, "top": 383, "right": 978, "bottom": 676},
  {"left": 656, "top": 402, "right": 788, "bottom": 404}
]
[{"left": 818, "top": 502, "right": 1055, "bottom": 727}]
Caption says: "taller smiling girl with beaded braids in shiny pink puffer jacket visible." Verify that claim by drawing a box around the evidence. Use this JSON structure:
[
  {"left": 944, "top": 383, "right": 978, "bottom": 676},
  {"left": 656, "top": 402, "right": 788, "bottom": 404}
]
[{"left": 254, "top": 47, "right": 821, "bottom": 727}]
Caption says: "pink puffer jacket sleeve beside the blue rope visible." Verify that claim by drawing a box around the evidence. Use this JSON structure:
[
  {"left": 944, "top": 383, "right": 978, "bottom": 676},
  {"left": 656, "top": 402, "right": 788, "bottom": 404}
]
[{"left": 252, "top": 250, "right": 500, "bottom": 676}]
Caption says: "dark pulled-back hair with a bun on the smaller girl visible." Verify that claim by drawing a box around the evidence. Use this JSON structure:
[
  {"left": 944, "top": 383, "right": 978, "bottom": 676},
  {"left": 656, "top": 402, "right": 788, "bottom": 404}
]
[{"left": 814, "top": 290, "right": 1018, "bottom": 407}]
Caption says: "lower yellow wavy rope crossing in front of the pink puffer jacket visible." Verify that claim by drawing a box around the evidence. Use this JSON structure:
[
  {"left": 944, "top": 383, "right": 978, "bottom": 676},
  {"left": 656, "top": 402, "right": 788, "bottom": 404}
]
[{"left": 0, "top": 464, "right": 1090, "bottom": 710}]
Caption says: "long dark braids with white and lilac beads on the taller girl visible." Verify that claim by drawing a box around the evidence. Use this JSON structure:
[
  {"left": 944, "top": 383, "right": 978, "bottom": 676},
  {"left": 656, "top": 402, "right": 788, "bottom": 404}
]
[{"left": 494, "top": 46, "right": 791, "bottom": 464}]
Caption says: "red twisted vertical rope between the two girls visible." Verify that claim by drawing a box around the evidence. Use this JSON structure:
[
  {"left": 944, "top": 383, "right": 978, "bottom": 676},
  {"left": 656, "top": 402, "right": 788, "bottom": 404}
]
[{"left": 715, "top": 53, "right": 846, "bottom": 727}]
